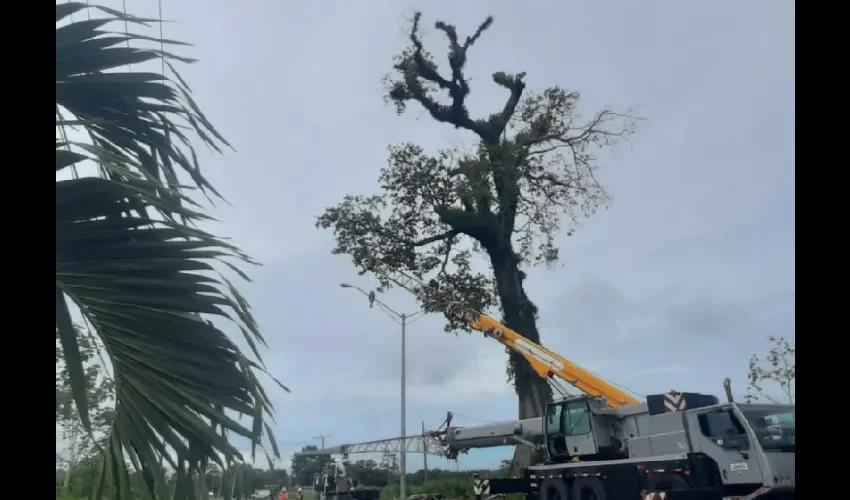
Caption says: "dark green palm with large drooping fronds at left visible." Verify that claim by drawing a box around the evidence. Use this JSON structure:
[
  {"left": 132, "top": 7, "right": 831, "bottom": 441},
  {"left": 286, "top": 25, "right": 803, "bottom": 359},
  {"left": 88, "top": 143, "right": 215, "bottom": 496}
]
[{"left": 56, "top": 3, "right": 286, "bottom": 500}]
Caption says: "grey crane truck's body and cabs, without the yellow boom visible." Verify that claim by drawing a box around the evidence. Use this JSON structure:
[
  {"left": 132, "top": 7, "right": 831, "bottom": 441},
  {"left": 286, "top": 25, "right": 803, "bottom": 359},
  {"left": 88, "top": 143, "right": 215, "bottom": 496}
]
[{"left": 473, "top": 392, "right": 796, "bottom": 500}]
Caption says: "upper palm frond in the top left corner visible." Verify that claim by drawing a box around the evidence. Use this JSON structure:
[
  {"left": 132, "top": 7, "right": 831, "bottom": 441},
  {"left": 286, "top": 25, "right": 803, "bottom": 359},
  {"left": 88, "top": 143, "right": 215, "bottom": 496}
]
[{"left": 56, "top": 3, "right": 229, "bottom": 211}]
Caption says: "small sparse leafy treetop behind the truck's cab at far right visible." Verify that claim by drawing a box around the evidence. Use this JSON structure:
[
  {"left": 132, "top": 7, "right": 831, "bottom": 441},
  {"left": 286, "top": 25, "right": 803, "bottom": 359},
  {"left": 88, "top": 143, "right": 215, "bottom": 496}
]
[{"left": 745, "top": 335, "right": 797, "bottom": 404}]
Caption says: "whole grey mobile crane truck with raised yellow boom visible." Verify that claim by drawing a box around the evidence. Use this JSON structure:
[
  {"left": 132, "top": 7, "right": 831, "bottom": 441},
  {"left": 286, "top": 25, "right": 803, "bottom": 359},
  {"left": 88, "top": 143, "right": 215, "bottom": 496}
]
[{"left": 374, "top": 268, "right": 796, "bottom": 500}]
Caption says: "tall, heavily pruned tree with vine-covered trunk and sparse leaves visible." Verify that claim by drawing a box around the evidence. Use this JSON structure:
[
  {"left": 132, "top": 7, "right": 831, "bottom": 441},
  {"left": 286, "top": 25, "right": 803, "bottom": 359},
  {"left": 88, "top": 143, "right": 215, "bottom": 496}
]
[{"left": 317, "top": 9, "right": 637, "bottom": 463}]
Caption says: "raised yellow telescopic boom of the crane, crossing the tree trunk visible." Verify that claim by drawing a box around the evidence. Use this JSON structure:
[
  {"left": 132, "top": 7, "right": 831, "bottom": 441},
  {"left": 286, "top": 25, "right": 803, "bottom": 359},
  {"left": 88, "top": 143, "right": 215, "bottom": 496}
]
[{"left": 382, "top": 269, "right": 640, "bottom": 408}]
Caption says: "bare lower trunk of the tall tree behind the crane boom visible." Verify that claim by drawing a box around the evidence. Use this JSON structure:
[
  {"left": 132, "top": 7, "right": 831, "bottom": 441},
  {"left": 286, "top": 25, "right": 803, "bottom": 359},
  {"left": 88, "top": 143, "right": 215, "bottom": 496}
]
[{"left": 490, "top": 242, "right": 552, "bottom": 468}]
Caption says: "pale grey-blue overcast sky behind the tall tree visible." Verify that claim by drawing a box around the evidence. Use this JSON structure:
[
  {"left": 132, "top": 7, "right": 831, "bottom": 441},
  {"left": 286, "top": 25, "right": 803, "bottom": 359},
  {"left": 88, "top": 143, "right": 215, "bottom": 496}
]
[{"left": 74, "top": 0, "right": 795, "bottom": 470}]
